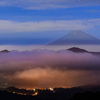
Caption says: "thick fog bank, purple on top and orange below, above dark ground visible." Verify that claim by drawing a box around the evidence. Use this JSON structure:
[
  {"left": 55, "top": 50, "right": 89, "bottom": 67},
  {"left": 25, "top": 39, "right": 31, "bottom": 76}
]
[{"left": 0, "top": 49, "right": 100, "bottom": 88}]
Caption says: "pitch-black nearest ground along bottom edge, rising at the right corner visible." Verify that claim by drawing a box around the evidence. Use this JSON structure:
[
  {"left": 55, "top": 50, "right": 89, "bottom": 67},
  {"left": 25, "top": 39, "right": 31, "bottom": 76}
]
[{"left": 0, "top": 91, "right": 100, "bottom": 100}]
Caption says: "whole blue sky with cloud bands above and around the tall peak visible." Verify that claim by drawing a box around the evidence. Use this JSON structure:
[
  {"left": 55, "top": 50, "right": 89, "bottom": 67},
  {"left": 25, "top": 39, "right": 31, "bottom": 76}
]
[{"left": 0, "top": 0, "right": 100, "bottom": 45}]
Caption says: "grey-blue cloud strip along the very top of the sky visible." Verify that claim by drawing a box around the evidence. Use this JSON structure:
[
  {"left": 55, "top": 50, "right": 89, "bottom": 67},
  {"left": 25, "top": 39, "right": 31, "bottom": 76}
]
[{"left": 0, "top": 0, "right": 100, "bottom": 10}]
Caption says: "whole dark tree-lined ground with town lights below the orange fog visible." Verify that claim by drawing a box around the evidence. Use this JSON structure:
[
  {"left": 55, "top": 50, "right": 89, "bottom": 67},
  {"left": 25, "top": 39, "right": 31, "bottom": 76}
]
[{"left": 0, "top": 86, "right": 100, "bottom": 100}]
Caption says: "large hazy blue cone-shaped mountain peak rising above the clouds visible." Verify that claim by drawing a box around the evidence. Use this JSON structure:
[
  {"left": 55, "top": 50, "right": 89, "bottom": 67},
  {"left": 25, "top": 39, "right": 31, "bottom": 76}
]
[{"left": 49, "top": 30, "right": 100, "bottom": 45}]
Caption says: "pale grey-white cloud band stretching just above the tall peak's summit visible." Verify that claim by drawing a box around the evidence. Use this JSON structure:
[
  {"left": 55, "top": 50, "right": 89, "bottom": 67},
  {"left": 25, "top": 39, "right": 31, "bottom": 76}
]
[{"left": 0, "top": 18, "right": 100, "bottom": 33}]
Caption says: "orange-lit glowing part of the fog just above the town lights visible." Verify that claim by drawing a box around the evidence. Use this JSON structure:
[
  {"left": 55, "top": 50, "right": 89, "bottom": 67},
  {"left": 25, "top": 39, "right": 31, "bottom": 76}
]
[{"left": 2, "top": 68, "right": 99, "bottom": 90}]
